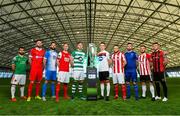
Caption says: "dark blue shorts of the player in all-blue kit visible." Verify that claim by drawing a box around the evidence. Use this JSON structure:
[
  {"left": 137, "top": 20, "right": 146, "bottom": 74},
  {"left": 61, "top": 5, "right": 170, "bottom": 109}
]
[{"left": 125, "top": 70, "right": 137, "bottom": 82}]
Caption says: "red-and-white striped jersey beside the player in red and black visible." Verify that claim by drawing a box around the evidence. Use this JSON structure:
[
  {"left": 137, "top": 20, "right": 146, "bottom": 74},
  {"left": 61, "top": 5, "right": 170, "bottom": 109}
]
[{"left": 138, "top": 53, "right": 151, "bottom": 75}]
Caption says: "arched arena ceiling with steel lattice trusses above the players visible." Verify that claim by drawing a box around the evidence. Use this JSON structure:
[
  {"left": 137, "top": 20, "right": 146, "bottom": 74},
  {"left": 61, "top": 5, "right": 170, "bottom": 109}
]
[{"left": 0, "top": 0, "right": 180, "bottom": 67}]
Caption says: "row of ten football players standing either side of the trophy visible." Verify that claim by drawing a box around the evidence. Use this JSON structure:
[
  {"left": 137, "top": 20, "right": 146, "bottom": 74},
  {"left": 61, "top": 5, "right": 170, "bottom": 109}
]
[{"left": 11, "top": 40, "right": 168, "bottom": 102}]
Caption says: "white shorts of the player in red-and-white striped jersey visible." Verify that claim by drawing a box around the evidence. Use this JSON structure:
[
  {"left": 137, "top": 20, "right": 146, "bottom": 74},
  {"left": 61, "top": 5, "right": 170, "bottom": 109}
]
[{"left": 113, "top": 73, "right": 125, "bottom": 84}]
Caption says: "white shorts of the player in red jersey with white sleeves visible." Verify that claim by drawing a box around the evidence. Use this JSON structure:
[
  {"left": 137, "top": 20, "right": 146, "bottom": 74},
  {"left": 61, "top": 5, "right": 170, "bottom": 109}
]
[{"left": 57, "top": 71, "right": 70, "bottom": 83}]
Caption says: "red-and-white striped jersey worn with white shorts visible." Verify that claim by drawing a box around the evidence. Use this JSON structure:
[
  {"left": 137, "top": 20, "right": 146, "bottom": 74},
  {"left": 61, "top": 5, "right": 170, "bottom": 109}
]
[{"left": 111, "top": 52, "right": 126, "bottom": 73}]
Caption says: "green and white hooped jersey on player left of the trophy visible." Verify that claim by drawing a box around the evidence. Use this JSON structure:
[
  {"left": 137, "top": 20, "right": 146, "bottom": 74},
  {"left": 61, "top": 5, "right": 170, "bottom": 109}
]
[{"left": 72, "top": 50, "right": 86, "bottom": 71}]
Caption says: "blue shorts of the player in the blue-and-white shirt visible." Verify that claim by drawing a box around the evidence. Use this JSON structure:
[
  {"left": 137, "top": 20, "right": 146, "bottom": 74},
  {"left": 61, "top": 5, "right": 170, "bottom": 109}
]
[{"left": 45, "top": 70, "right": 57, "bottom": 81}]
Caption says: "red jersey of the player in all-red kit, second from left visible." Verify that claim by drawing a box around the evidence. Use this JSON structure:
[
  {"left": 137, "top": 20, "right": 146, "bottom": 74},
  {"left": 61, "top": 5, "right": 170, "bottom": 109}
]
[{"left": 29, "top": 48, "right": 45, "bottom": 69}]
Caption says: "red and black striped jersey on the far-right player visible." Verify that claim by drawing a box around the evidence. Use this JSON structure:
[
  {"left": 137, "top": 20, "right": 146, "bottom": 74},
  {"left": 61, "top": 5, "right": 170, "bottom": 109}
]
[{"left": 151, "top": 50, "right": 165, "bottom": 72}]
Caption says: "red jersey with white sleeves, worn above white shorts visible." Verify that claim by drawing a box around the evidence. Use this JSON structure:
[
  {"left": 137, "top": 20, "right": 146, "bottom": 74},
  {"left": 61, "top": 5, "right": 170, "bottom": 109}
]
[{"left": 58, "top": 51, "right": 71, "bottom": 72}]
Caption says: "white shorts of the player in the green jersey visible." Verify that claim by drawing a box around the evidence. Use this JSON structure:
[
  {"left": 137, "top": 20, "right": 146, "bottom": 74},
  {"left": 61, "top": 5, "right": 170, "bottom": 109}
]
[{"left": 11, "top": 74, "right": 26, "bottom": 85}]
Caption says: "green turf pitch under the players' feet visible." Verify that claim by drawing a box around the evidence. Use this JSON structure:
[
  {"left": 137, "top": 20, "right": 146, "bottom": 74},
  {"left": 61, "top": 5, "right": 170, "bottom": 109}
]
[{"left": 0, "top": 78, "right": 180, "bottom": 115}]
